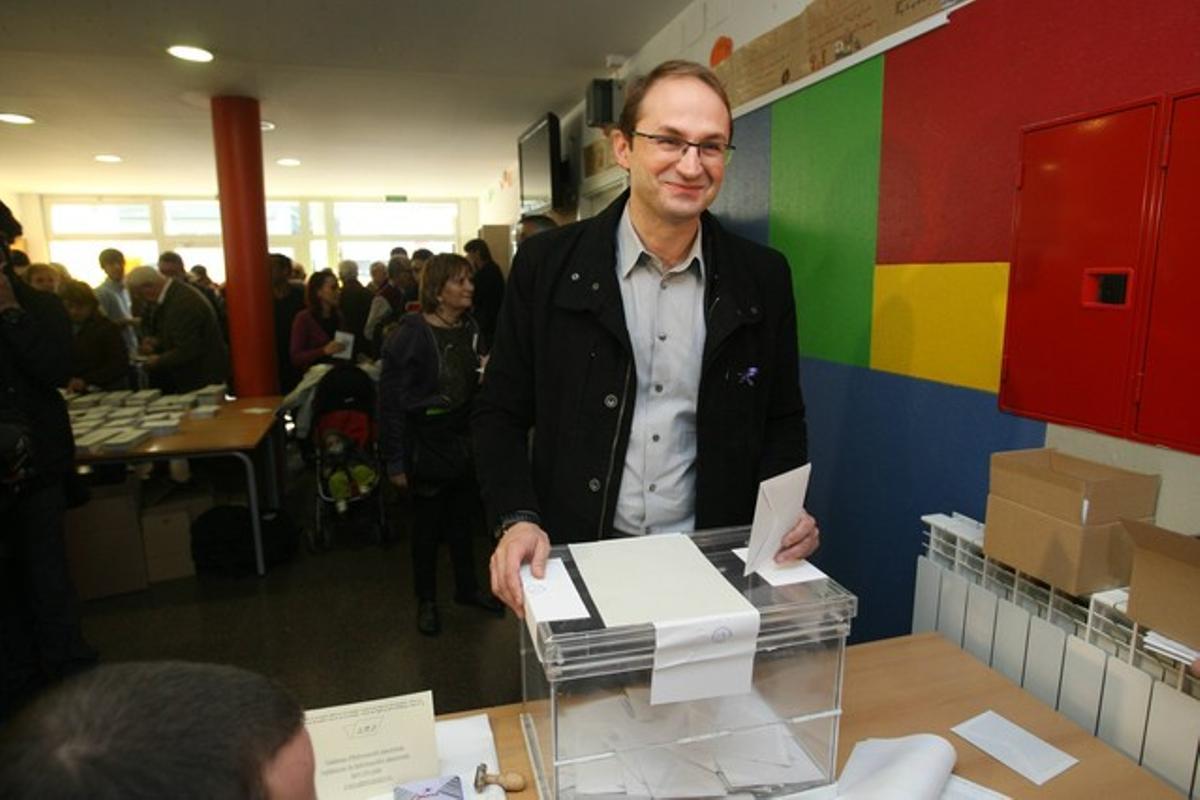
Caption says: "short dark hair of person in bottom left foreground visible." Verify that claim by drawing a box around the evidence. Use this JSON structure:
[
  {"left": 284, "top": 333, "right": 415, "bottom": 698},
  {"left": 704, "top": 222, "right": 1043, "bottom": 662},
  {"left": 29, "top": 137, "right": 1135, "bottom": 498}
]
[{"left": 0, "top": 661, "right": 304, "bottom": 800}]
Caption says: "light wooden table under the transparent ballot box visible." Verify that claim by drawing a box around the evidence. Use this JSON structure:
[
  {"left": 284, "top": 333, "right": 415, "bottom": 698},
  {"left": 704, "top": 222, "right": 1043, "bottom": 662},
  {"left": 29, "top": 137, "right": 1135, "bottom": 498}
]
[{"left": 475, "top": 633, "right": 1180, "bottom": 800}]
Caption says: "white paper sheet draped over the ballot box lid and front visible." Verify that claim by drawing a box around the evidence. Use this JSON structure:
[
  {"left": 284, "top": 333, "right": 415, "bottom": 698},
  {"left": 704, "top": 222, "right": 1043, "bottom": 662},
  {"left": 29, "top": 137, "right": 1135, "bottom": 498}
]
[{"left": 570, "top": 534, "right": 758, "bottom": 703}]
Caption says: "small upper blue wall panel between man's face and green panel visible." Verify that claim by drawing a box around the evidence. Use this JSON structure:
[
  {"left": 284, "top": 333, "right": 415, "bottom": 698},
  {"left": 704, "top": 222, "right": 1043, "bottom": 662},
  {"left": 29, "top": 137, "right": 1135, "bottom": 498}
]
[{"left": 710, "top": 106, "right": 770, "bottom": 245}]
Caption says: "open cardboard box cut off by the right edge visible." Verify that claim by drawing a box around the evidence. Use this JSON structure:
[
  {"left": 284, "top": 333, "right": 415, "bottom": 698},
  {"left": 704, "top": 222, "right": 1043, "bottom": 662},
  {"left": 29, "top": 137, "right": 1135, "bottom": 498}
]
[{"left": 1122, "top": 519, "right": 1200, "bottom": 648}]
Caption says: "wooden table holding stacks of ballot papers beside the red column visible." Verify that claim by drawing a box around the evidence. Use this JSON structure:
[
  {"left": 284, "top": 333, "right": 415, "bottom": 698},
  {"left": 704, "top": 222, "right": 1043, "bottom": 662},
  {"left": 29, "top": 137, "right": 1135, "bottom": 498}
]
[{"left": 76, "top": 396, "right": 283, "bottom": 575}]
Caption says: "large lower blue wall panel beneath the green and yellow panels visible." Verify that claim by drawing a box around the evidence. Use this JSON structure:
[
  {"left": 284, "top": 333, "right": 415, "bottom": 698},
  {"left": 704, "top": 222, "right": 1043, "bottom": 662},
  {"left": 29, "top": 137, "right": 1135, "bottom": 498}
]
[{"left": 800, "top": 359, "right": 1045, "bottom": 642}]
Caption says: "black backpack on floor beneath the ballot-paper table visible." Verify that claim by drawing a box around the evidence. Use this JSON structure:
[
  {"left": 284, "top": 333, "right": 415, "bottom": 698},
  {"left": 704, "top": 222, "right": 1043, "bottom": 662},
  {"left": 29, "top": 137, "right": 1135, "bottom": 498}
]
[{"left": 192, "top": 505, "right": 300, "bottom": 576}]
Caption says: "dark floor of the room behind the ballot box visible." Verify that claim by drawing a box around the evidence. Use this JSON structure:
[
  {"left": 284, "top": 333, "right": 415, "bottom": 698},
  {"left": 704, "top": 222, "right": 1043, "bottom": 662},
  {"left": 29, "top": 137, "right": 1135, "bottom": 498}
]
[{"left": 83, "top": 448, "right": 521, "bottom": 714}]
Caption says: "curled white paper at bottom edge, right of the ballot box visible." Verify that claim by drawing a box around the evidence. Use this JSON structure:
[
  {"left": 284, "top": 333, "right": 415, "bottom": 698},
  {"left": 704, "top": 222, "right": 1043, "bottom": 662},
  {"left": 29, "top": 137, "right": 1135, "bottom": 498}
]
[{"left": 838, "top": 733, "right": 958, "bottom": 800}]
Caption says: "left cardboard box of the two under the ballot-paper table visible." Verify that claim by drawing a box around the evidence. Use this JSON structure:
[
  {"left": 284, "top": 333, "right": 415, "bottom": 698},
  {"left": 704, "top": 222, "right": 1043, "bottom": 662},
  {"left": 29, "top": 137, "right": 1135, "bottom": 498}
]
[{"left": 66, "top": 476, "right": 146, "bottom": 600}]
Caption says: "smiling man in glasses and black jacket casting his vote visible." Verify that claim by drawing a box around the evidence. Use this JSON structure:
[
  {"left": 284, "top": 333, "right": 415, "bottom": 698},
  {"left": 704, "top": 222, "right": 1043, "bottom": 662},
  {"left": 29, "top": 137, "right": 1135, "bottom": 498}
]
[{"left": 474, "top": 61, "right": 818, "bottom": 614}]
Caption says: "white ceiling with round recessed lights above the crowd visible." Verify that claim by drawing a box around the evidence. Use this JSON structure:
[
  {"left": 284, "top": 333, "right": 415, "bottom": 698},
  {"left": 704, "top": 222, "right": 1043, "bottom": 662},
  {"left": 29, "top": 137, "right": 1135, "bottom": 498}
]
[{"left": 0, "top": 0, "right": 688, "bottom": 198}]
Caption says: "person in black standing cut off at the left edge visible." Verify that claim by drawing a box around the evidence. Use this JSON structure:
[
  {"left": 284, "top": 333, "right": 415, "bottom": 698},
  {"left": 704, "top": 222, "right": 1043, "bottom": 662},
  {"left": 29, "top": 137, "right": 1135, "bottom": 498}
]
[{"left": 0, "top": 203, "right": 95, "bottom": 718}]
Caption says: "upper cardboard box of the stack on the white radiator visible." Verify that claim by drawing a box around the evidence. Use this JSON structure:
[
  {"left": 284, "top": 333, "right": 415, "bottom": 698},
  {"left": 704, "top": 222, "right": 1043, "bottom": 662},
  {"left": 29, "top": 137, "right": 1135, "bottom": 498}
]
[{"left": 988, "top": 447, "right": 1159, "bottom": 525}]
